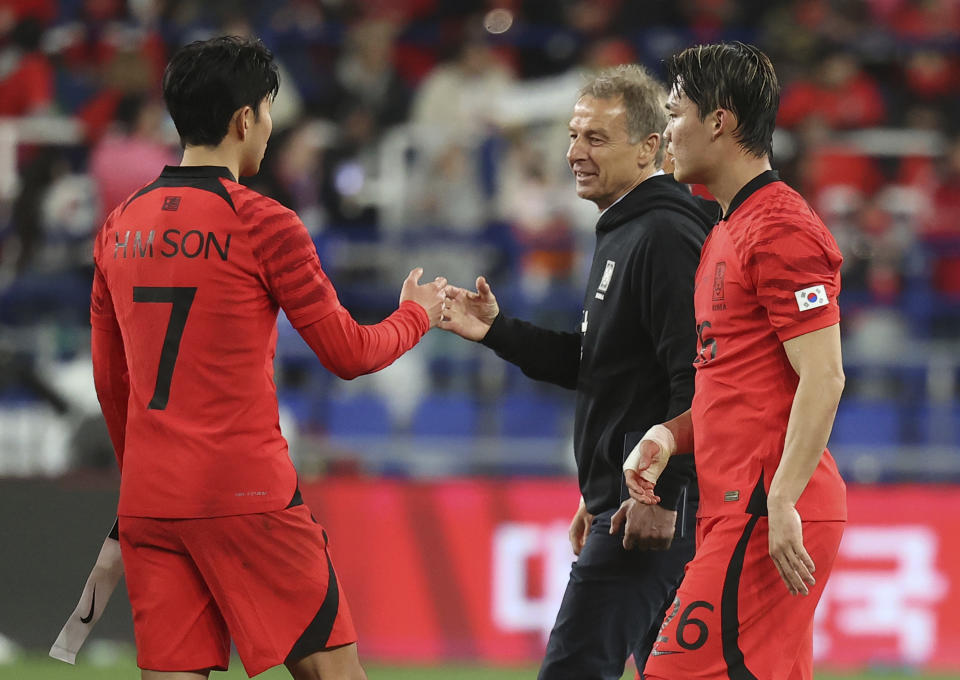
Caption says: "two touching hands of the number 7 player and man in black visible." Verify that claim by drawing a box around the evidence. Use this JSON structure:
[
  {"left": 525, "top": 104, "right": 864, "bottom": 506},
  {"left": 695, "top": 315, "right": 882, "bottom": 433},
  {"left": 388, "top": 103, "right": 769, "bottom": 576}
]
[{"left": 400, "top": 267, "right": 500, "bottom": 342}]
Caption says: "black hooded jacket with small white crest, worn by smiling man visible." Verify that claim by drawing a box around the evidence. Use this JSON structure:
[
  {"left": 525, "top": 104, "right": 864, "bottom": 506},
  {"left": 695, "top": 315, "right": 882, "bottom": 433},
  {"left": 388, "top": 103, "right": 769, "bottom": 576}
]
[{"left": 482, "top": 175, "right": 713, "bottom": 514}]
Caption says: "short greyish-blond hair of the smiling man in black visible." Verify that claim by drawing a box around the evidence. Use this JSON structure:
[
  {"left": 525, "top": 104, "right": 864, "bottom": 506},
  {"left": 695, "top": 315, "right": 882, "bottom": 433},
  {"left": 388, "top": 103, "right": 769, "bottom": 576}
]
[{"left": 580, "top": 64, "right": 667, "bottom": 168}]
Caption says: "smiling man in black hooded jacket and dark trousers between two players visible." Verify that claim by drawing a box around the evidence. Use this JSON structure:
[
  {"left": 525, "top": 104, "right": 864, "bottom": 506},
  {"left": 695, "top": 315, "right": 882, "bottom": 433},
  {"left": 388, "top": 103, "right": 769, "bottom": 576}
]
[{"left": 440, "top": 66, "right": 711, "bottom": 680}]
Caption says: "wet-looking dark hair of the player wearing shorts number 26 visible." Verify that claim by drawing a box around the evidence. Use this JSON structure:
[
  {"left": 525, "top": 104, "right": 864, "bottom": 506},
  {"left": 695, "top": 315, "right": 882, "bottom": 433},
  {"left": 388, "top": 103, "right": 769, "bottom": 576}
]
[{"left": 666, "top": 42, "right": 780, "bottom": 158}]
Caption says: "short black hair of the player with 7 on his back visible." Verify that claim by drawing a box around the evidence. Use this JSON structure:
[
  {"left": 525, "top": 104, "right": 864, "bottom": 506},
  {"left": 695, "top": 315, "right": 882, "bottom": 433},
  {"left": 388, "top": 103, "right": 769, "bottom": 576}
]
[{"left": 163, "top": 36, "right": 280, "bottom": 147}]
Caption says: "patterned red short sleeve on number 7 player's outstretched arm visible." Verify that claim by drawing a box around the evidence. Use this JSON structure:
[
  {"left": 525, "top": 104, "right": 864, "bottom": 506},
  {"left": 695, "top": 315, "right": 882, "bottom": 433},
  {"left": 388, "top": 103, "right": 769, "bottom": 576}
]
[{"left": 233, "top": 183, "right": 340, "bottom": 328}]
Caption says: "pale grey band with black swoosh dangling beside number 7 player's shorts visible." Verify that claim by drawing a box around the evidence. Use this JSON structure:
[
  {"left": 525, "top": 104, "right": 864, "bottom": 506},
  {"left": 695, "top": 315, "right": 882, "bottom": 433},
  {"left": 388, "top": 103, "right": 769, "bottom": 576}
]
[{"left": 50, "top": 537, "right": 123, "bottom": 664}]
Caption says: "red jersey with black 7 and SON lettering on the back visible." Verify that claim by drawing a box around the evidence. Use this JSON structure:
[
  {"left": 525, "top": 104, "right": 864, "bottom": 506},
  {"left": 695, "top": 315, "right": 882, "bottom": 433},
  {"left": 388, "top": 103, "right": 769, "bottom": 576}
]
[{"left": 91, "top": 167, "right": 427, "bottom": 517}]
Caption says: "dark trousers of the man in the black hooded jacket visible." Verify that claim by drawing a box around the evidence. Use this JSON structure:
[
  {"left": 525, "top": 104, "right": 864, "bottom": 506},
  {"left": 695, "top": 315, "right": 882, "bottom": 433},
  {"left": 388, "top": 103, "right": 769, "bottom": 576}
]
[{"left": 537, "top": 487, "right": 698, "bottom": 680}]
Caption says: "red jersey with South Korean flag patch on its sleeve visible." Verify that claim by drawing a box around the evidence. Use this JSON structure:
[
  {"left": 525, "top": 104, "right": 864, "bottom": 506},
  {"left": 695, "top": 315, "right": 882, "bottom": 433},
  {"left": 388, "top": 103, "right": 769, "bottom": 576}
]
[{"left": 692, "top": 171, "right": 846, "bottom": 520}]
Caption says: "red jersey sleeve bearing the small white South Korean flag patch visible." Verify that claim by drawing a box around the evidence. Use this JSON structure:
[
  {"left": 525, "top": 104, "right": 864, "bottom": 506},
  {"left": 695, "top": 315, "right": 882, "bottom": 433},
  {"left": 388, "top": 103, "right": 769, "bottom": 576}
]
[{"left": 737, "top": 185, "right": 843, "bottom": 341}]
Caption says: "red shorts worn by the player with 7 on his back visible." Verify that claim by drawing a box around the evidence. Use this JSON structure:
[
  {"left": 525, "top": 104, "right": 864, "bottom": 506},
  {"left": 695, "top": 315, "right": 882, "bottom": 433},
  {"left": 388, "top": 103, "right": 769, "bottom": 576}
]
[{"left": 120, "top": 505, "right": 357, "bottom": 676}]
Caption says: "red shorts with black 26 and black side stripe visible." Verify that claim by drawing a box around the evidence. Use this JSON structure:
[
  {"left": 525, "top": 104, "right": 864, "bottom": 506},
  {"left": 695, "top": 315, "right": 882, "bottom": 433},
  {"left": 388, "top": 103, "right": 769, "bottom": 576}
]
[{"left": 643, "top": 514, "right": 845, "bottom": 680}]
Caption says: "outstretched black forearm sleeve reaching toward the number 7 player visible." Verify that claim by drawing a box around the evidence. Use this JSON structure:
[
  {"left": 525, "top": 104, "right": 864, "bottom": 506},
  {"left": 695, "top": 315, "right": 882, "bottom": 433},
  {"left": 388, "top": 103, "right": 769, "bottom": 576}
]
[{"left": 480, "top": 314, "right": 580, "bottom": 390}]
